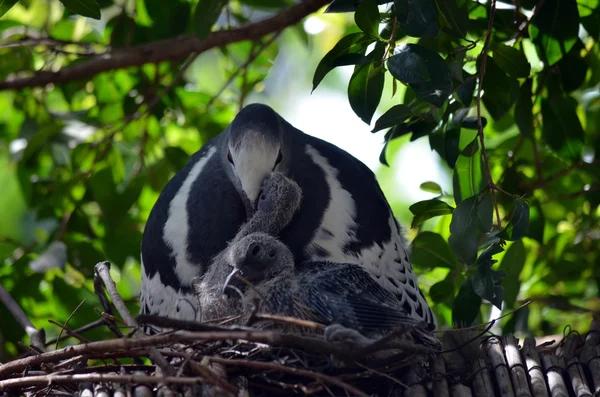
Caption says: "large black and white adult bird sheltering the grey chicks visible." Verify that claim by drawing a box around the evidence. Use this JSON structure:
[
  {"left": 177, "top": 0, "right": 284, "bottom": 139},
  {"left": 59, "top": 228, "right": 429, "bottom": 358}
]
[{"left": 141, "top": 104, "right": 435, "bottom": 324}]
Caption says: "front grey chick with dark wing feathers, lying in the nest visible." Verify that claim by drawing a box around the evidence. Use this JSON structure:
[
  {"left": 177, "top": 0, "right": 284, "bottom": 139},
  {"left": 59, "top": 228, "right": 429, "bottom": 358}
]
[{"left": 225, "top": 233, "right": 421, "bottom": 335}]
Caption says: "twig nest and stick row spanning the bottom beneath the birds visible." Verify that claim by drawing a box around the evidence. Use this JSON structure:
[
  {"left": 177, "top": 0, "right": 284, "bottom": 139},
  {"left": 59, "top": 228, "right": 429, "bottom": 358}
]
[{"left": 0, "top": 263, "right": 600, "bottom": 397}]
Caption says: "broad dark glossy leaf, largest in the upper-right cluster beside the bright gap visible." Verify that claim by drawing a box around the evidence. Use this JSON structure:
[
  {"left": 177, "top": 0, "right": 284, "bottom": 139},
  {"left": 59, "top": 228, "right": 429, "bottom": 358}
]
[{"left": 387, "top": 44, "right": 452, "bottom": 108}]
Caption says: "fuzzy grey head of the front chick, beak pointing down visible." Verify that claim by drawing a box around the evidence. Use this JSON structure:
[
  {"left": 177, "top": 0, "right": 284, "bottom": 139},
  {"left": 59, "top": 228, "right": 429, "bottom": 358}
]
[{"left": 223, "top": 233, "right": 294, "bottom": 291}]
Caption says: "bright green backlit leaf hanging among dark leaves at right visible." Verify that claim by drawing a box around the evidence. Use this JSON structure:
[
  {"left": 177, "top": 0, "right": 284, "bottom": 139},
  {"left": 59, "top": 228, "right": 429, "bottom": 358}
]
[{"left": 453, "top": 137, "right": 486, "bottom": 203}]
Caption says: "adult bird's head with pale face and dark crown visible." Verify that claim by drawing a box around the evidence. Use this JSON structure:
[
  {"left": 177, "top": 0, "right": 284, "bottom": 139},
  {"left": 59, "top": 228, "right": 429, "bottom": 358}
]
[{"left": 223, "top": 104, "right": 290, "bottom": 217}]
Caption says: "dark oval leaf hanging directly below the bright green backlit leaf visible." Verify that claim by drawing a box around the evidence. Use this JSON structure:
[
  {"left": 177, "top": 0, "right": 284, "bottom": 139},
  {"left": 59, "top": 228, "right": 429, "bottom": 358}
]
[{"left": 448, "top": 196, "right": 478, "bottom": 265}]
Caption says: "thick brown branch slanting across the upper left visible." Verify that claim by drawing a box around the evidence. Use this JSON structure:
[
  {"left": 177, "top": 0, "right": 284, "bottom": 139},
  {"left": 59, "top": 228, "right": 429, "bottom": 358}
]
[{"left": 0, "top": 0, "right": 329, "bottom": 90}]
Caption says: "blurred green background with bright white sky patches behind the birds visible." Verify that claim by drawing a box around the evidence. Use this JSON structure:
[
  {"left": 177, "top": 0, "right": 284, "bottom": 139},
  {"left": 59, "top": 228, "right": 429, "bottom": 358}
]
[{"left": 0, "top": 0, "right": 600, "bottom": 361}]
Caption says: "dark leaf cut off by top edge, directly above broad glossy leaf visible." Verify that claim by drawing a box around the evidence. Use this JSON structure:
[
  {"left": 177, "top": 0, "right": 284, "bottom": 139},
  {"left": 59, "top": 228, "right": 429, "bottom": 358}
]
[{"left": 394, "top": 0, "right": 438, "bottom": 37}]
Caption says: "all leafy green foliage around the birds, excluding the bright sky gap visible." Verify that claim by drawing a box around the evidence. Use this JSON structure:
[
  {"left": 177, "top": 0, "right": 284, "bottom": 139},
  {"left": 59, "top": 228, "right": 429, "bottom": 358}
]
[{"left": 0, "top": 0, "right": 600, "bottom": 354}]
